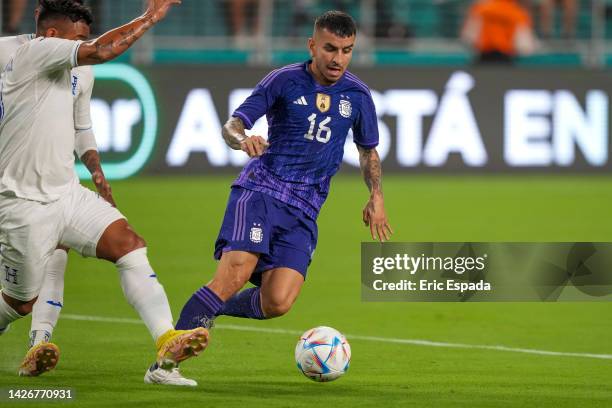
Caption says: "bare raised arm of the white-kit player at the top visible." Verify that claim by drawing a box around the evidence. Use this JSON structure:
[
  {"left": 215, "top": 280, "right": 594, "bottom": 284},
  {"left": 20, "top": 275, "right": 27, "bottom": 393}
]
[{"left": 77, "top": 0, "right": 181, "bottom": 65}]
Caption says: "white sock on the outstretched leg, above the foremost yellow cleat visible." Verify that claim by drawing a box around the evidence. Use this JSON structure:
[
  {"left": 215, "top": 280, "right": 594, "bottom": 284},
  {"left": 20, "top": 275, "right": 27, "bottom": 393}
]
[{"left": 116, "top": 248, "right": 174, "bottom": 340}]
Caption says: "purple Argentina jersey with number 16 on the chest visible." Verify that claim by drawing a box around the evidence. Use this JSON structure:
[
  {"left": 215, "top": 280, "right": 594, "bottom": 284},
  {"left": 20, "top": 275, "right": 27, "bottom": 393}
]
[{"left": 232, "top": 61, "right": 378, "bottom": 219}]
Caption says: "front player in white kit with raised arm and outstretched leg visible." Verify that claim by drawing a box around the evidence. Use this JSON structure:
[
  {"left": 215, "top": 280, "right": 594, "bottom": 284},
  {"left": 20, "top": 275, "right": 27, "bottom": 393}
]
[{"left": 0, "top": 0, "right": 208, "bottom": 380}]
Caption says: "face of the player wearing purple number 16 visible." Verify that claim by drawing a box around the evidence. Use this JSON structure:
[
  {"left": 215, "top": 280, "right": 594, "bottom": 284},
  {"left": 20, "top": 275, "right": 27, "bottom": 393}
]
[{"left": 308, "top": 29, "right": 355, "bottom": 85}]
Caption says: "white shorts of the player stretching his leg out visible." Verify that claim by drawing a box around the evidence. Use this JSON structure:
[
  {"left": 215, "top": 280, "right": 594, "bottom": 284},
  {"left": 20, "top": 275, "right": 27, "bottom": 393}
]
[{"left": 0, "top": 183, "right": 125, "bottom": 301}]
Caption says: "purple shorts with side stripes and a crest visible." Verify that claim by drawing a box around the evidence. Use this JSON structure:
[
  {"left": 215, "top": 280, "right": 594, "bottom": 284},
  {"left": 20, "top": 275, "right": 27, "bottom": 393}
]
[{"left": 215, "top": 186, "right": 318, "bottom": 286}]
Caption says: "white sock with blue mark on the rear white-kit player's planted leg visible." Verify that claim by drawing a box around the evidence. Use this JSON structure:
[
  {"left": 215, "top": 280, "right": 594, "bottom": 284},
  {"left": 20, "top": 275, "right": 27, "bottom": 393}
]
[{"left": 30, "top": 249, "right": 68, "bottom": 347}]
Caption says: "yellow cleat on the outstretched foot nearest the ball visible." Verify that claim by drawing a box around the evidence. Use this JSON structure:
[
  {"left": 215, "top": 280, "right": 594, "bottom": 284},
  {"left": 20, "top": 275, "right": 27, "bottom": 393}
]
[{"left": 157, "top": 327, "right": 208, "bottom": 370}]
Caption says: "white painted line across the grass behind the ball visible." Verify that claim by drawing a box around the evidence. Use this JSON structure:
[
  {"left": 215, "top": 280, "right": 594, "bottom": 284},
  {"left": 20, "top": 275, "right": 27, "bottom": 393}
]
[{"left": 61, "top": 314, "right": 612, "bottom": 360}]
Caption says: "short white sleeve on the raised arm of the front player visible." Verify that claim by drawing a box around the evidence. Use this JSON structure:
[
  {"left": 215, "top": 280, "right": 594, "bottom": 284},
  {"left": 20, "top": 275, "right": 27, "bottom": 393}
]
[{"left": 24, "top": 37, "right": 82, "bottom": 71}]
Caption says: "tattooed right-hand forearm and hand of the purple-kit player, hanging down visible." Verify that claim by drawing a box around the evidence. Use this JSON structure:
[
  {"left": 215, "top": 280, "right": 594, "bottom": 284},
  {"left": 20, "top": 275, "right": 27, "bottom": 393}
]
[{"left": 357, "top": 146, "right": 393, "bottom": 242}]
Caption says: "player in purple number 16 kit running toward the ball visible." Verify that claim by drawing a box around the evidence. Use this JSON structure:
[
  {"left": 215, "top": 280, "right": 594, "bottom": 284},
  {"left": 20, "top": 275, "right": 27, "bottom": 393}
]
[{"left": 176, "top": 11, "right": 392, "bottom": 340}]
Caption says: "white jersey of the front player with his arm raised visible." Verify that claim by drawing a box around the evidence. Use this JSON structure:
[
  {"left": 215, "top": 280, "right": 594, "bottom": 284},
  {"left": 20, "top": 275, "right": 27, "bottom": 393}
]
[{"left": 0, "top": 36, "right": 82, "bottom": 202}]
